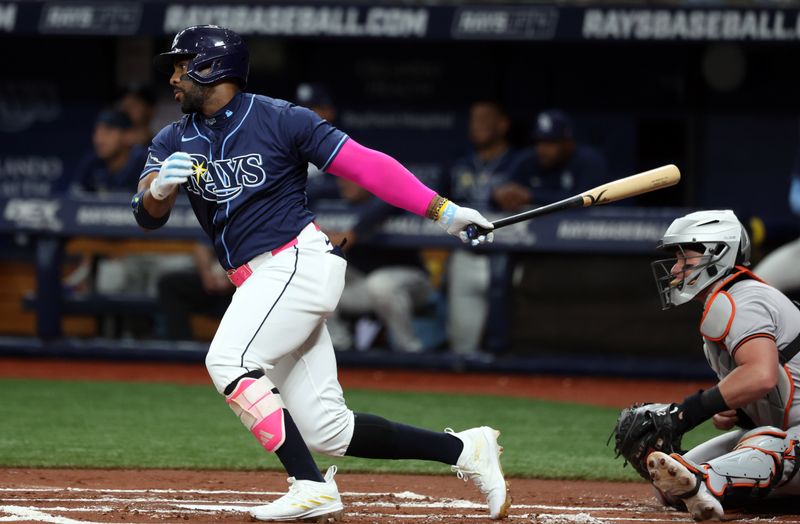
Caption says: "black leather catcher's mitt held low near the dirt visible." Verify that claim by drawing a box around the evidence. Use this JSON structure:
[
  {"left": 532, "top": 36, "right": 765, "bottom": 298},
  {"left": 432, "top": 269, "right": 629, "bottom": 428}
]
[{"left": 608, "top": 403, "right": 683, "bottom": 480}]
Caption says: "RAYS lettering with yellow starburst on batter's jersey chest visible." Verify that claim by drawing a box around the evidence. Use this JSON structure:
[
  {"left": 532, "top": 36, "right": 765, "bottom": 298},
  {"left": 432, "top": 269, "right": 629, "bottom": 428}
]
[{"left": 186, "top": 153, "right": 267, "bottom": 203}]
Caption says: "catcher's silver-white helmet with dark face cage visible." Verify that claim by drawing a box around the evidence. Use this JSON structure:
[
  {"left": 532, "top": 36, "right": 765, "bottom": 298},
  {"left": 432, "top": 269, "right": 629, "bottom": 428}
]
[{"left": 651, "top": 210, "right": 750, "bottom": 309}]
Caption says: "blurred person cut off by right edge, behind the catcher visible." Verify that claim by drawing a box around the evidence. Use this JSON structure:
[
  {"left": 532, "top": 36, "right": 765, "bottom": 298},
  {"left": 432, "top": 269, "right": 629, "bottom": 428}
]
[{"left": 753, "top": 166, "right": 800, "bottom": 293}]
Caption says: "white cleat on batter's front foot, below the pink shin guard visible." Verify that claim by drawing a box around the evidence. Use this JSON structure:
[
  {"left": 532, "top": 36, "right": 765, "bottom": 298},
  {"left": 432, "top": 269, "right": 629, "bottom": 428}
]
[{"left": 250, "top": 466, "right": 344, "bottom": 524}]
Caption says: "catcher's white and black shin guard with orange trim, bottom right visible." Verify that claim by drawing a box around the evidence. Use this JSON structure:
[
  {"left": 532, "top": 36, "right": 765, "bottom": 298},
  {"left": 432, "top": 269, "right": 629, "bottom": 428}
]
[{"left": 702, "top": 426, "right": 798, "bottom": 505}]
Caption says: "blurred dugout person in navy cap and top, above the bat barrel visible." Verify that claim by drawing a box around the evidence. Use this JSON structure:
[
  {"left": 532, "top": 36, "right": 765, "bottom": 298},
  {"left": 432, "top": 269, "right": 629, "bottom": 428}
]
[{"left": 514, "top": 109, "right": 608, "bottom": 205}]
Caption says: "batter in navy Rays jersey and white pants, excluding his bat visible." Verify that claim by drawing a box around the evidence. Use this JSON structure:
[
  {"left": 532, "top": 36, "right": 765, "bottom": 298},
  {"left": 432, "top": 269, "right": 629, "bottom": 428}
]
[{"left": 132, "top": 26, "right": 511, "bottom": 522}]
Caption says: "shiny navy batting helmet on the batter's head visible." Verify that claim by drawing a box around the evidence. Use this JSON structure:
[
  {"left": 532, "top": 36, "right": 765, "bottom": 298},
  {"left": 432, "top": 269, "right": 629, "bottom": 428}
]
[{"left": 153, "top": 25, "right": 250, "bottom": 89}]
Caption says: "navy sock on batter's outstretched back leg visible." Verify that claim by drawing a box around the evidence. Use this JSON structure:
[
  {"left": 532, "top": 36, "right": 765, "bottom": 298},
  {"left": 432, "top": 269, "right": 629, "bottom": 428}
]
[{"left": 345, "top": 413, "right": 464, "bottom": 465}]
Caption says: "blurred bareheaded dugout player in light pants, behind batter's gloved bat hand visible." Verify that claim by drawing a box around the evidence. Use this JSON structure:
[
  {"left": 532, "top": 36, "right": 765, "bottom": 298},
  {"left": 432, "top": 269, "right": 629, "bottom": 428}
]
[{"left": 447, "top": 100, "right": 530, "bottom": 355}]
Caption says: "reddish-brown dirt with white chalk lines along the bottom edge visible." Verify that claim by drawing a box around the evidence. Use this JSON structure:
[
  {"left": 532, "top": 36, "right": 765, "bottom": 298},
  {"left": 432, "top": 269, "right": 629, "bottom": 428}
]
[{"left": 0, "top": 469, "right": 800, "bottom": 524}]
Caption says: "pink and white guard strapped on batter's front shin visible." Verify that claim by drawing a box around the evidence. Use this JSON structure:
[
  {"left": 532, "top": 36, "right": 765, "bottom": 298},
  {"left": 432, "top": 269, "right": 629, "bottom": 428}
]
[{"left": 226, "top": 376, "right": 286, "bottom": 452}]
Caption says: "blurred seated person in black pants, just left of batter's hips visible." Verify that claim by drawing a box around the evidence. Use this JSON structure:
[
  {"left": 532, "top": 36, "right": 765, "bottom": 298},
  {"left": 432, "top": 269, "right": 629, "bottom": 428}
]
[{"left": 158, "top": 242, "right": 236, "bottom": 340}]
